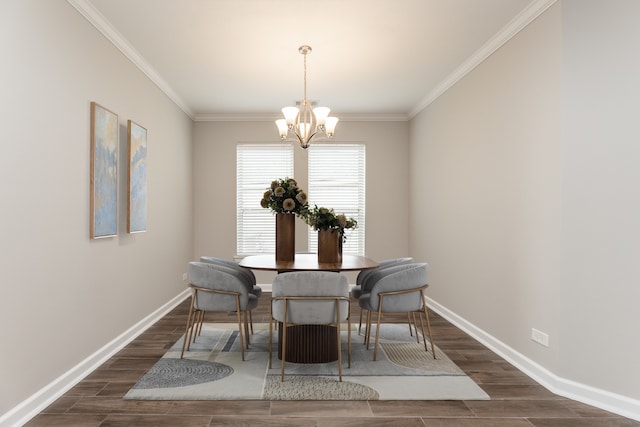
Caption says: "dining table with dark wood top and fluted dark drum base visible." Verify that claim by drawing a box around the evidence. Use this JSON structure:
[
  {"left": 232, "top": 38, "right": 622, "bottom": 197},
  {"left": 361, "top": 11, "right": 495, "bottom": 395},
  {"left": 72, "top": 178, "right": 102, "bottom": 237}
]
[{"left": 239, "top": 253, "right": 378, "bottom": 363}]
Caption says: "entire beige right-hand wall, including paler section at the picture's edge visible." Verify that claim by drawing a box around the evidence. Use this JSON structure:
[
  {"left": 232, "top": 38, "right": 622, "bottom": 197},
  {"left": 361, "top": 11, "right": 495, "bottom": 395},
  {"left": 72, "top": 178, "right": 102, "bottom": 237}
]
[{"left": 410, "top": 0, "right": 640, "bottom": 407}]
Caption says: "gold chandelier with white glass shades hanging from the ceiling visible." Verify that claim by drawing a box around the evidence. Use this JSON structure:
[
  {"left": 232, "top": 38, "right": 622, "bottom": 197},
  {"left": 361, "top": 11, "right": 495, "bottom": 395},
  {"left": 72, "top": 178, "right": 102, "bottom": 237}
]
[{"left": 276, "top": 45, "right": 338, "bottom": 149}]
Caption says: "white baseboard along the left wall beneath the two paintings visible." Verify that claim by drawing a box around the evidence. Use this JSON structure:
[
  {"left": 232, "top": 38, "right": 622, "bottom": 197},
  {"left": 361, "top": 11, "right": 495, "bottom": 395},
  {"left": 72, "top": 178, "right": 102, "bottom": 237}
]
[{"left": 0, "top": 289, "right": 191, "bottom": 427}]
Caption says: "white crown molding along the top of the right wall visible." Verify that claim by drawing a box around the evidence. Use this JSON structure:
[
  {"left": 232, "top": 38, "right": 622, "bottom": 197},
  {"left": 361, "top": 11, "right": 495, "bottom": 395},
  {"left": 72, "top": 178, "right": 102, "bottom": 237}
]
[{"left": 408, "top": 0, "right": 557, "bottom": 119}]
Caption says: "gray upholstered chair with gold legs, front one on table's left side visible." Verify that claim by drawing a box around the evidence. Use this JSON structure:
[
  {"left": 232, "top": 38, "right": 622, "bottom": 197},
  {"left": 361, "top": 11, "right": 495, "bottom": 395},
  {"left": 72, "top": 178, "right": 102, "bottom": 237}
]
[{"left": 180, "top": 262, "right": 258, "bottom": 360}]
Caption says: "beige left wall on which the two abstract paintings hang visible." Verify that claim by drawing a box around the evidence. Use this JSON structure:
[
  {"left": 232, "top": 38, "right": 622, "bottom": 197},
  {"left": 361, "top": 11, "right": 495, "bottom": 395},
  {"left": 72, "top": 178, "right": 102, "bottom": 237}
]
[{"left": 0, "top": 0, "right": 193, "bottom": 415}]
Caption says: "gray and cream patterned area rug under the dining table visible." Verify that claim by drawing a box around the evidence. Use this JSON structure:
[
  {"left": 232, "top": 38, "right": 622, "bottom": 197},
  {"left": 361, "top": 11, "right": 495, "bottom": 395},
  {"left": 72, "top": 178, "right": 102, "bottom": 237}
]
[{"left": 124, "top": 323, "right": 489, "bottom": 400}]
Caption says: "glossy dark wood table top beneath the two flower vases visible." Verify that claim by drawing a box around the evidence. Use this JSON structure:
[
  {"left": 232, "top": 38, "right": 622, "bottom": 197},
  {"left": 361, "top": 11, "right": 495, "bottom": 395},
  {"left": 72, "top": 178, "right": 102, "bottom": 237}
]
[{"left": 240, "top": 254, "right": 378, "bottom": 271}]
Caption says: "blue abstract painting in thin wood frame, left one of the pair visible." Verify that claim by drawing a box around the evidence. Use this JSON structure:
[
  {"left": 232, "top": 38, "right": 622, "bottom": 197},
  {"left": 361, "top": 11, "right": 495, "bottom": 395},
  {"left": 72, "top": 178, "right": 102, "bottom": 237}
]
[{"left": 90, "top": 102, "right": 118, "bottom": 239}]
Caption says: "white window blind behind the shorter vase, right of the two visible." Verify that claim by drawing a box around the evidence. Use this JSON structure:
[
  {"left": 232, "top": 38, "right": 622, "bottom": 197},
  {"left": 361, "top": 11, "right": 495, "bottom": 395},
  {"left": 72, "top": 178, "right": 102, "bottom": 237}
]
[{"left": 307, "top": 144, "right": 366, "bottom": 255}]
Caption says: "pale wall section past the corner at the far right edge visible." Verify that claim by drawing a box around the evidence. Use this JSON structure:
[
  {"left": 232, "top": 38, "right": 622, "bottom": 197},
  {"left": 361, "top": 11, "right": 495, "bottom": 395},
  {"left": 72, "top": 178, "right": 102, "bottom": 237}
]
[{"left": 557, "top": 0, "right": 640, "bottom": 402}]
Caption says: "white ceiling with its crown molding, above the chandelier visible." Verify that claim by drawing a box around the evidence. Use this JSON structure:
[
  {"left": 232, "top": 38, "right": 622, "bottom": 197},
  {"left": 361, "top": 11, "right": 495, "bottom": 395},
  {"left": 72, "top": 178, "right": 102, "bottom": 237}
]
[{"left": 68, "top": 0, "right": 555, "bottom": 120}]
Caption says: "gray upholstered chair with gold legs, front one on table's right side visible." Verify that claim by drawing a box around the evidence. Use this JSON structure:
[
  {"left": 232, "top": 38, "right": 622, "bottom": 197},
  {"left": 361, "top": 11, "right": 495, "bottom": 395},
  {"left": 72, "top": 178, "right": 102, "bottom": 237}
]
[{"left": 358, "top": 263, "right": 436, "bottom": 360}]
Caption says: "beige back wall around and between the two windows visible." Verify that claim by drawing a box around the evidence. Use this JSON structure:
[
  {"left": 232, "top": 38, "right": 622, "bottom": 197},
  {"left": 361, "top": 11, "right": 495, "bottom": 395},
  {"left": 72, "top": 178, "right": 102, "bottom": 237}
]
[{"left": 194, "top": 121, "right": 409, "bottom": 283}]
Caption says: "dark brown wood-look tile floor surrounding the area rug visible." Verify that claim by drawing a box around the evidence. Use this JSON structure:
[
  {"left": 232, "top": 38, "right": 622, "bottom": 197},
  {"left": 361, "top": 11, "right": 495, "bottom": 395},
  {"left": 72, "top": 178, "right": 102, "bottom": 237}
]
[{"left": 26, "top": 293, "right": 640, "bottom": 427}]
